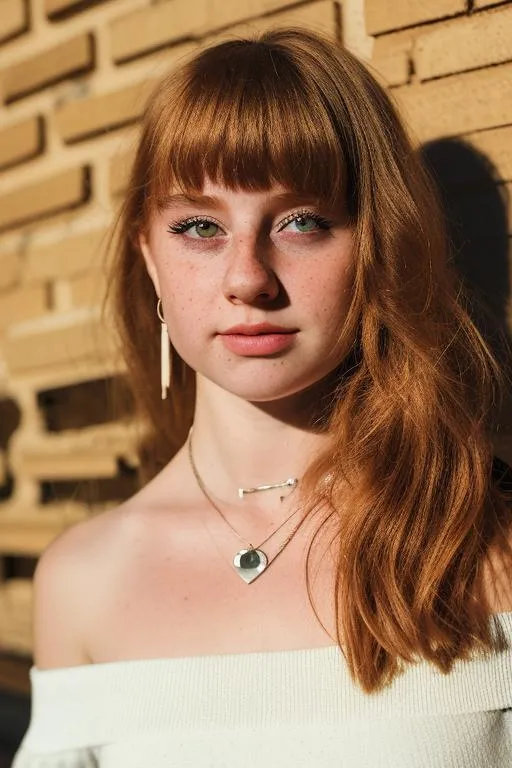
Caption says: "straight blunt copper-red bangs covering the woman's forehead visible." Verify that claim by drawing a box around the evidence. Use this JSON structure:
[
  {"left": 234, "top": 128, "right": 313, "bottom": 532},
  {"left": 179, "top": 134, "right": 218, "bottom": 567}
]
[{"left": 146, "top": 40, "right": 350, "bottom": 208}]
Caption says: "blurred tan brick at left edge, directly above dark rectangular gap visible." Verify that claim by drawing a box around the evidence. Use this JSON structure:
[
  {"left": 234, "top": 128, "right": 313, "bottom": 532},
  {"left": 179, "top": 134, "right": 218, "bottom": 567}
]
[{"left": 2, "top": 320, "right": 114, "bottom": 375}]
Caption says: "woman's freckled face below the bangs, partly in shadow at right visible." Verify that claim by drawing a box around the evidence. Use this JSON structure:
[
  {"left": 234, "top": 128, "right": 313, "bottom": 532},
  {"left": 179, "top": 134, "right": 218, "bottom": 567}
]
[{"left": 140, "top": 181, "right": 353, "bottom": 402}]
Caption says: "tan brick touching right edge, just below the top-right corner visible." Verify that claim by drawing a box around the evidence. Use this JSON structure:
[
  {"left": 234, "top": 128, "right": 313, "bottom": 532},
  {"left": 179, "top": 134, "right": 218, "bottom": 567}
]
[{"left": 413, "top": 7, "right": 512, "bottom": 80}]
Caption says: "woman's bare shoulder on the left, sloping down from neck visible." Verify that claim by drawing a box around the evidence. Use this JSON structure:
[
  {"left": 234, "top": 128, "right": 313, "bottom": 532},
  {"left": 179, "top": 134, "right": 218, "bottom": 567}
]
[{"left": 32, "top": 456, "right": 190, "bottom": 669}]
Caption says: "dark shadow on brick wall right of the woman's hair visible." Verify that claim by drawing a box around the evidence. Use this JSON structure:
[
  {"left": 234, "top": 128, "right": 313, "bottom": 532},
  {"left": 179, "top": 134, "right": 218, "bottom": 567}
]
[{"left": 420, "top": 139, "right": 512, "bottom": 465}]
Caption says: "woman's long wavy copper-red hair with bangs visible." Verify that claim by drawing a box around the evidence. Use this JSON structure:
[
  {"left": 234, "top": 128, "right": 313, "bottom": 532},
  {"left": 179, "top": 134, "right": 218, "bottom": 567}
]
[{"left": 105, "top": 29, "right": 511, "bottom": 693}]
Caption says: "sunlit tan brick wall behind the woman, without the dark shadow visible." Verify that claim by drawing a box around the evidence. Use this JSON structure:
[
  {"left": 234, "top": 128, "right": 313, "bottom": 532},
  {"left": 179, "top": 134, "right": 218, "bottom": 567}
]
[{"left": 0, "top": 0, "right": 512, "bottom": 672}]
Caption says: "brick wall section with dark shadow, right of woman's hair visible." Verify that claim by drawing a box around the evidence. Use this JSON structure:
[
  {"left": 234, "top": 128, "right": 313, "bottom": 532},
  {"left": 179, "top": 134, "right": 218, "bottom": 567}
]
[{"left": 365, "top": 0, "right": 512, "bottom": 456}]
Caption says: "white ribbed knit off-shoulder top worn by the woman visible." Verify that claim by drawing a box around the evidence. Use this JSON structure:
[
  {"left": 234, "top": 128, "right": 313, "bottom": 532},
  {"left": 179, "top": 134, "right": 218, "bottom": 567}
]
[{"left": 13, "top": 612, "right": 512, "bottom": 768}]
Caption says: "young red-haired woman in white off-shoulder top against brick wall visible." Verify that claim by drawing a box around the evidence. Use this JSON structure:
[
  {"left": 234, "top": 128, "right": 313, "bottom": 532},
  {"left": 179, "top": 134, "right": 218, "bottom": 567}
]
[{"left": 14, "top": 30, "right": 512, "bottom": 768}]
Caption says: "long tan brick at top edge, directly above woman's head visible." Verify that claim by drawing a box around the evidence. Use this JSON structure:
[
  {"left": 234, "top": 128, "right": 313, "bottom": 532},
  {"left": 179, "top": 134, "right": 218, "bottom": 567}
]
[{"left": 111, "top": 0, "right": 314, "bottom": 62}]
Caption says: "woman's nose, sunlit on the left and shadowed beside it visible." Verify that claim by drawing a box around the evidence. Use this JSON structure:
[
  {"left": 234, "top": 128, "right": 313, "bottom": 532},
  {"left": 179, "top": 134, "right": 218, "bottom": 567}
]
[{"left": 223, "top": 237, "right": 279, "bottom": 304}]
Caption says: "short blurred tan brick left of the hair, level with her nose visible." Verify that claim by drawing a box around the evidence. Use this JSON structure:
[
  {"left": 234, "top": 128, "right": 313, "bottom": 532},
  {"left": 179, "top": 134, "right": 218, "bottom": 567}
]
[{"left": 23, "top": 229, "right": 110, "bottom": 282}]
